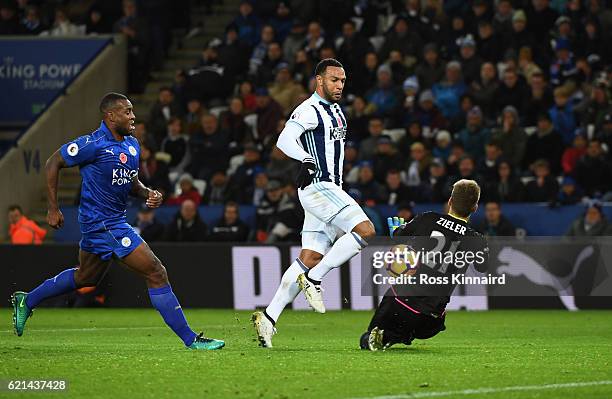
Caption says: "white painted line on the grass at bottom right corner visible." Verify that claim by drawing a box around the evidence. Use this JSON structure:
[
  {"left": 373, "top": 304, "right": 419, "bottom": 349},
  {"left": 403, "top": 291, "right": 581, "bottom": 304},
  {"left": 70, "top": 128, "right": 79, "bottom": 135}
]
[{"left": 354, "top": 380, "right": 612, "bottom": 399}]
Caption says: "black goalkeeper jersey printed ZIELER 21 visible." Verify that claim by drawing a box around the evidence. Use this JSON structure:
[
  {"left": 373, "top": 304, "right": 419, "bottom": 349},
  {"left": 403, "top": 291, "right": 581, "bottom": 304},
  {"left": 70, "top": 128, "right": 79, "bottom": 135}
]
[{"left": 391, "top": 212, "right": 489, "bottom": 317}]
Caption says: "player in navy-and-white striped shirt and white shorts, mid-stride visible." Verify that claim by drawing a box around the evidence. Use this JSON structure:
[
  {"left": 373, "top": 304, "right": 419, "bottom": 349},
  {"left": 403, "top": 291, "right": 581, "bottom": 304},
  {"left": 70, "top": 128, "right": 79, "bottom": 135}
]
[{"left": 252, "top": 58, "right": 375, "bottom": 348}]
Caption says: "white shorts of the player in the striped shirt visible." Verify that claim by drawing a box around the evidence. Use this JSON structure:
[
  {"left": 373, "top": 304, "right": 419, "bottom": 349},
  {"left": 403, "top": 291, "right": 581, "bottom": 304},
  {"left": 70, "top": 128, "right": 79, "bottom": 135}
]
[{"left": 298, "top": 182, "right": 370, "bottom": 255}]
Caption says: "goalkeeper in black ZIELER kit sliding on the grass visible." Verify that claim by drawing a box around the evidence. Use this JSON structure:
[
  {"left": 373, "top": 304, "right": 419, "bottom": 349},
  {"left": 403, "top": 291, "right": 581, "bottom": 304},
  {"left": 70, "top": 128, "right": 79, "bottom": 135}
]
[{"left": 360, "top": 180, "right": 489, "bottom": 351}]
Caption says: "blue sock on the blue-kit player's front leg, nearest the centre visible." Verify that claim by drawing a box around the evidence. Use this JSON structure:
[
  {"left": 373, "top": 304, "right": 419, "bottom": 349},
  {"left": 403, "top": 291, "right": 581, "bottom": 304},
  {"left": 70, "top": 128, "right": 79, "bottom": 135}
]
[{"left": 149, "top": 285, "right": 197, "bottom": 346}]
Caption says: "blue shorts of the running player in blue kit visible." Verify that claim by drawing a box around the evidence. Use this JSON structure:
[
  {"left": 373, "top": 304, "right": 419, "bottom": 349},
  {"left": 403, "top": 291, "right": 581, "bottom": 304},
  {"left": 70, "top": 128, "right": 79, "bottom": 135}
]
[{"left": 79, "top": 223, "right": 144, "bottom": 260}]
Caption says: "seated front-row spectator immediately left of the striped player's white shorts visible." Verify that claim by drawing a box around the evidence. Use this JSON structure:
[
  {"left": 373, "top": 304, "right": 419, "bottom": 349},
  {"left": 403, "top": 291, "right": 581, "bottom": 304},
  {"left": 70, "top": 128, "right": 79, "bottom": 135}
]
[{"left": 255, "top": 180, "right": 304, "bottom": 243}]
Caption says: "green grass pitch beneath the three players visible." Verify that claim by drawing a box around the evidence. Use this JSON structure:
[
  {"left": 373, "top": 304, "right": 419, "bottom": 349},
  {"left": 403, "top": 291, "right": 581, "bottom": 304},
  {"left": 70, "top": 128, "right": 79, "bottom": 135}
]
[{"left": 0, "top": 309, "right": 612, "bottom": 399}]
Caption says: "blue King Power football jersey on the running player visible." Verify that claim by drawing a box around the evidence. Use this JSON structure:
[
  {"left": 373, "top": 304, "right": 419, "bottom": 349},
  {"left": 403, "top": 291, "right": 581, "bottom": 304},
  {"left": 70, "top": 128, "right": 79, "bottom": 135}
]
[{"left": 60, "top": 122, "right": 140, "bottom": 233}]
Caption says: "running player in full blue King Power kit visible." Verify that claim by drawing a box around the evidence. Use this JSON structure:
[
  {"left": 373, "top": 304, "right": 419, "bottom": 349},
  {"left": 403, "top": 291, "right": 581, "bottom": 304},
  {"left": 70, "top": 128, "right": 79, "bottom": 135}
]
[{"left": 11, "top": 93, "right": 225, "bottom": 350}]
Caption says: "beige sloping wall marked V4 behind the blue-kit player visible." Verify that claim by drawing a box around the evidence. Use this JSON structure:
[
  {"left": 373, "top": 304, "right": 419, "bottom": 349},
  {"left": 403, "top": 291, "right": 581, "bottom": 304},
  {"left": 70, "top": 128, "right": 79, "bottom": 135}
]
[{"left": 0, "top": 36, "right": 127, "bottom": 241}]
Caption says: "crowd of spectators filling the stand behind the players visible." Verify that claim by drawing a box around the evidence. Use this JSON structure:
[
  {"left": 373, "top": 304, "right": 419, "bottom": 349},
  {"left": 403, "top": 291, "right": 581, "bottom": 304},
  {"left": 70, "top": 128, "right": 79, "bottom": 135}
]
[{"left": 3, "top": 0, "right": 612, "bottom": 241}]
